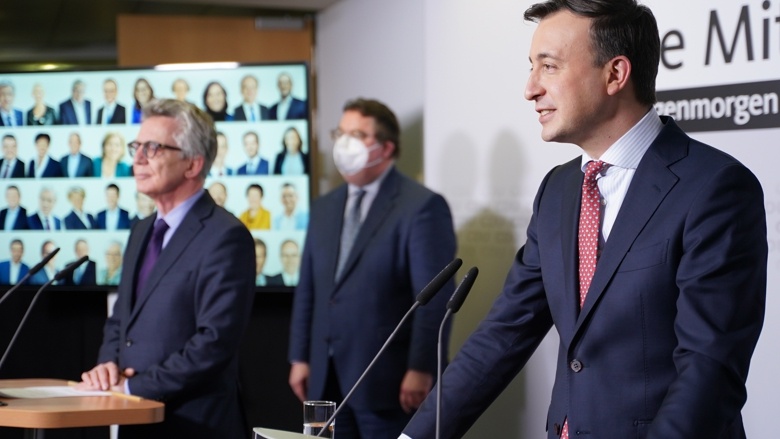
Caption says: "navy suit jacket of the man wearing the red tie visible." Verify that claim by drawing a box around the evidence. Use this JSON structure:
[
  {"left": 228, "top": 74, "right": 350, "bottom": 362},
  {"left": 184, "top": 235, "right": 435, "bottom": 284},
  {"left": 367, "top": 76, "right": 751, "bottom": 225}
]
[{"left": 405, "top": 118, "right": 767, "bottom": 439}]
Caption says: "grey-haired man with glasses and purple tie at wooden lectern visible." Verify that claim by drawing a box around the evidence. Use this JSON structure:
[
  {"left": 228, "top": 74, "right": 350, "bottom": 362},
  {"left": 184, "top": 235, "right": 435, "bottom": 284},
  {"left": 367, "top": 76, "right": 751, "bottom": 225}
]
[{"left": 79, "top": 99, "right": 255, "bottom": 439}]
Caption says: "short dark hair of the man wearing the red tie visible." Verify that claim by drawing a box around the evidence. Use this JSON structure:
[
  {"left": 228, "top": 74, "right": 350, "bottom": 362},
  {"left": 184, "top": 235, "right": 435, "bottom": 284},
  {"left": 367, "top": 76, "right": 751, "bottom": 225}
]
[{"left": 523, "top": 0, "right": 661, "bottom": 105}]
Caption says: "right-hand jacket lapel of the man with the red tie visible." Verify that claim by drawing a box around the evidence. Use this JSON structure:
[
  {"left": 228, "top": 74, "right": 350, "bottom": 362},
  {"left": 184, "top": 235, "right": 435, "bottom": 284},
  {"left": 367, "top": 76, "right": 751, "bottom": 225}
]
[{"left": 575, "top": 120, "right": 688, "bottom": 332}]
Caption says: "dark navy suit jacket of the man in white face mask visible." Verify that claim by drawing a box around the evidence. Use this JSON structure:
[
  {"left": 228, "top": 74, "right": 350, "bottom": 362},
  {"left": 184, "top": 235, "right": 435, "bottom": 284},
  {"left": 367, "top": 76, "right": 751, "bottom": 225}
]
[{"left": 290, "top": 169, "right": 455, "bottom": 410}]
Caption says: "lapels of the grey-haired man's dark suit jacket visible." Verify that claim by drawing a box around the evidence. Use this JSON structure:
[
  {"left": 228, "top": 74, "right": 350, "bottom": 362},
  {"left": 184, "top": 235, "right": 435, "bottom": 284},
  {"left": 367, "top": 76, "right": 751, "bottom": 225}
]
[{"left": 131, "top": 193, "right": 215, "bottom": 321}]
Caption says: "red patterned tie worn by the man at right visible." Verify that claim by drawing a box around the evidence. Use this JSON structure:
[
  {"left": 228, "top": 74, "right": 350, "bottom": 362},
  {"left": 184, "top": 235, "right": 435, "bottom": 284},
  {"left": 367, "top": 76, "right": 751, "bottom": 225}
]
[{"left": 561, "top": 161, "right": 606, "bottom": 439}]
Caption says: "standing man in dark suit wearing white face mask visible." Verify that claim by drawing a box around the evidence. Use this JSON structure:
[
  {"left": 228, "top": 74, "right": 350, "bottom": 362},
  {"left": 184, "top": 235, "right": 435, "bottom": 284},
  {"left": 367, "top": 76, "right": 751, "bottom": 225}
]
[{"left": 290, "top": 99, "right": 456, "bottom": 439}]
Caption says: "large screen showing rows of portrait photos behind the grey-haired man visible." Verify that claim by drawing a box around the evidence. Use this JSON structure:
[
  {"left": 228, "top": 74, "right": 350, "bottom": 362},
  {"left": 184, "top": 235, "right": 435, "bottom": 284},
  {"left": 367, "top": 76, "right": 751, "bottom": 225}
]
[{"left": 0, "top": 63, "right": 311, "bottom": 290}]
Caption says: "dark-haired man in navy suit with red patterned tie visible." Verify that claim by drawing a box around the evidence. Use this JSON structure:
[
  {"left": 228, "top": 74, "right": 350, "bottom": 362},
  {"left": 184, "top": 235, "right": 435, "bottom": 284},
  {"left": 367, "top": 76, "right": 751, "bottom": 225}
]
[{"left": 404, "top": 0, "right": 767, "bottom": 439}]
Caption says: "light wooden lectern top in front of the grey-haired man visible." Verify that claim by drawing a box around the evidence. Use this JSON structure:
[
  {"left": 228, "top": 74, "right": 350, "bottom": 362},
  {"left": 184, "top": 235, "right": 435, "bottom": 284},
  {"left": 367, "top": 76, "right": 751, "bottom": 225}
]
[{"left": 0, "top": 379, "right": 165, "bottom": 439}]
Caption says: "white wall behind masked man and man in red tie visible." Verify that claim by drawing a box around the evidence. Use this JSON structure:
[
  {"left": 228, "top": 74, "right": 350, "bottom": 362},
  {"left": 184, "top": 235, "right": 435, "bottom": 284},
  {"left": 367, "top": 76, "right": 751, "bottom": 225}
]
[{"left": 316, "top": 0, "right": 780, "bottom": 439}]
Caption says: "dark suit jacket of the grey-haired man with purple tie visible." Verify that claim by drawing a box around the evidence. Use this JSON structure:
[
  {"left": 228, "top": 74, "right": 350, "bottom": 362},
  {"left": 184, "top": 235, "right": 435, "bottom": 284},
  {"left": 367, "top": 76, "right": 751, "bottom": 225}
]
[{"left": 98, "top": 193, "right": 255, "bottom": 439}]
